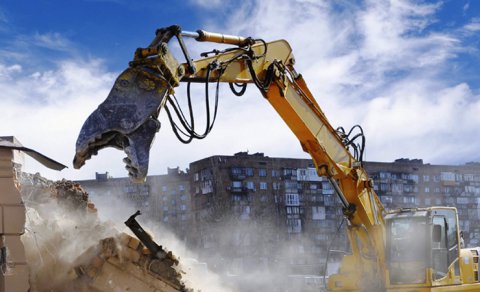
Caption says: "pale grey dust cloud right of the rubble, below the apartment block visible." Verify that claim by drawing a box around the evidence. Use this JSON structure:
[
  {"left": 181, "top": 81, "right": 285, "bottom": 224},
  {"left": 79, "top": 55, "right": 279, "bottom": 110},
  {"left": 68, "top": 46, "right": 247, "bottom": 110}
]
[{"left": 90, "top": 190, "right": 330, "bottom": 292}]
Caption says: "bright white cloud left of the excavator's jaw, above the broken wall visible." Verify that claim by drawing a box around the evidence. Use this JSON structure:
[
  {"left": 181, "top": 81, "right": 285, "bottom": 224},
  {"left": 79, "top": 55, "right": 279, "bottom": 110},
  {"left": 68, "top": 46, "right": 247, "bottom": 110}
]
[{"left": 0, "top": 60, "right": 122, "bottom": 179}]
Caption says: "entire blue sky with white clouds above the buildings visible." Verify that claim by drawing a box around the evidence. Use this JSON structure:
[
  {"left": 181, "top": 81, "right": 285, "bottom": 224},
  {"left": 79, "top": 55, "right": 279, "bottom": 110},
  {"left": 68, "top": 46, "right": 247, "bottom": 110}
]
[{"left": 0, "top": 0, "right": 480, "bottom": 179}]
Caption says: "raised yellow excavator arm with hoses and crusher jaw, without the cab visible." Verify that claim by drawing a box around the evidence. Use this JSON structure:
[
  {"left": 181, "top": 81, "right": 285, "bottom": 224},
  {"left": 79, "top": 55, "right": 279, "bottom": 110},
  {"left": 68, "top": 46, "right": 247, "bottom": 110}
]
[{"left": 74, "top": 26, "right": 385, "bottom": 291}]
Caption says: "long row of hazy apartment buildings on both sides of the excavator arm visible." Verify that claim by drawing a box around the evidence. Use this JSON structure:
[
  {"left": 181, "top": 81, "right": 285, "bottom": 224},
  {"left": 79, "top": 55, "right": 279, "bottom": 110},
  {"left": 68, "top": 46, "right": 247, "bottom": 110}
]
[{"left": 77, "top": 152, "right": 480, "bottom": 275}]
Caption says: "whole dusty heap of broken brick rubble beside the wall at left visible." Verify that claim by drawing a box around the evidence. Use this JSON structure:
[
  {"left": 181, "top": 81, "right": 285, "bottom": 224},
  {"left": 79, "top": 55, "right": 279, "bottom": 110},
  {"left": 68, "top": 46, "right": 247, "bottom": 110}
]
[{"left": 18, "top": 173, "right": 191, "bottom": 292}]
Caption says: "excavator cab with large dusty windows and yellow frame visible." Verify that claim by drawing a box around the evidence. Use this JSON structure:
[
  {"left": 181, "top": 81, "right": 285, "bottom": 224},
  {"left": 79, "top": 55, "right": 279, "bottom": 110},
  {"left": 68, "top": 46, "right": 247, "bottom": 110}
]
[{"left": 385, "top": 207, "right": 459, "bottom": 288}]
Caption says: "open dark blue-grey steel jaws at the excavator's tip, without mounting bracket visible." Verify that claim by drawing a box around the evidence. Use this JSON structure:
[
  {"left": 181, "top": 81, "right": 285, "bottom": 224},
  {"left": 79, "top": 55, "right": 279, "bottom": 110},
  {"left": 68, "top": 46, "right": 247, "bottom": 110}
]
[{"left": 73, "top": 67, "right": 168, "bottom": 182}]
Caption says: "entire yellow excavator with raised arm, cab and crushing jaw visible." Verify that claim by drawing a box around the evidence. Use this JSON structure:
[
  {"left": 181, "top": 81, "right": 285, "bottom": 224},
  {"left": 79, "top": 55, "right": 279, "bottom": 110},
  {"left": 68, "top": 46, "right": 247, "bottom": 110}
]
[{"left": 74, "top": 26, "right": 480, "bottom": 292}]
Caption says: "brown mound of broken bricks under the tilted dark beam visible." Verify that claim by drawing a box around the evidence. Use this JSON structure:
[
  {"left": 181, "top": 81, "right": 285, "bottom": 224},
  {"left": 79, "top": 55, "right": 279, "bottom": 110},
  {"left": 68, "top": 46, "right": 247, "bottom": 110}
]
[{"left": 72, "top": 233, "right": 191, "bottom": 292}]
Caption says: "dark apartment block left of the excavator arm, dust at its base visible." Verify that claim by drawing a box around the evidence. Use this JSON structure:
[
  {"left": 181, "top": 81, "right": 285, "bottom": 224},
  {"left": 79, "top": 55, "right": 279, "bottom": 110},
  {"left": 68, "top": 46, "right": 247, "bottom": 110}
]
[{"left": 190, "top": 152, "right": 346, "bottom": 274}]
